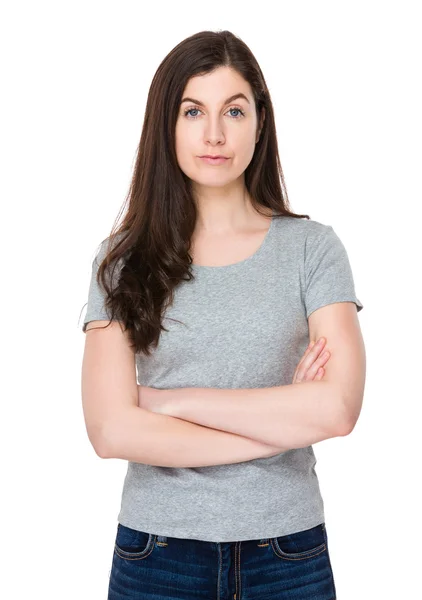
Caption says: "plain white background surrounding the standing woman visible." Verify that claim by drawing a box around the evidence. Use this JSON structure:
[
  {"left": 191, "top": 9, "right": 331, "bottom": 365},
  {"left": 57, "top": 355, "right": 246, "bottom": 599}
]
[{"left": 0, "top": 0, "right": 422, "bottom": 600}]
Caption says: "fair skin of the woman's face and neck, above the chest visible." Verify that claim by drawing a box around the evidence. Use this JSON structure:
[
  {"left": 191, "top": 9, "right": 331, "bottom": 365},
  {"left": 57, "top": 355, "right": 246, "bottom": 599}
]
[{"left": 175, "top": 67, "right": 265, "bottom": 237}]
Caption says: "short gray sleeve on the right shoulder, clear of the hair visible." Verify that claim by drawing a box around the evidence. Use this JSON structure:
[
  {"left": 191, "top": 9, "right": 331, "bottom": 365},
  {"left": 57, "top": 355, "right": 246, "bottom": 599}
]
[{"left": 305, "top": 225, "right": 363, "bottom": 317}]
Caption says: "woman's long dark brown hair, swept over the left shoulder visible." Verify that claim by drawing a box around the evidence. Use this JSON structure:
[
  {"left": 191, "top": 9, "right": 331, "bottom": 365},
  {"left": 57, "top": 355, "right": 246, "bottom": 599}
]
[{"left": 82, "top": 31, "right": 310, "bottom": 356}]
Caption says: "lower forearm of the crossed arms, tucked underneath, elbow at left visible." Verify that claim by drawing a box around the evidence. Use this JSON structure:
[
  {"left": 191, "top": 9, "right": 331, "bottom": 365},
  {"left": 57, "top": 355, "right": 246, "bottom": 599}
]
[{"left": 101, "top": 406, "right": 288, "bottom": 467}]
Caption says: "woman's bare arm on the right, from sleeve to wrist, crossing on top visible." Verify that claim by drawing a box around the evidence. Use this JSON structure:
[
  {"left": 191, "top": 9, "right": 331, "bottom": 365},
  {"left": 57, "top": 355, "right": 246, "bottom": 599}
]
[{"left": 140, "top": 302, "right": 366, "bottom": 449}]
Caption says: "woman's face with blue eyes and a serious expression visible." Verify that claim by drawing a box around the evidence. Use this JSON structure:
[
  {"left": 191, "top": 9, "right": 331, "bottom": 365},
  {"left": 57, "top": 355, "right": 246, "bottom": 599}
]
[{"left": 176, "top": 67, "right": 260, "bottom": 188}]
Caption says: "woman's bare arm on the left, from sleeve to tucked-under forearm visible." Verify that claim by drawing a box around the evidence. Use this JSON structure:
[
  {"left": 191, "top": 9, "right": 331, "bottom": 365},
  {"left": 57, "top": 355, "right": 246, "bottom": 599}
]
[{"left": 81, "top": 322, "right": 283, "bottom": 467}]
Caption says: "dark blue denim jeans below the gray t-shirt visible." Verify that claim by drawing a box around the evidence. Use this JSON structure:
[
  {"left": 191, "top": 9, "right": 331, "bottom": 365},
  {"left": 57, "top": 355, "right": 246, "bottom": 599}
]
[{"left": 108, "top": 523, "right": 336, "bottom": 600}]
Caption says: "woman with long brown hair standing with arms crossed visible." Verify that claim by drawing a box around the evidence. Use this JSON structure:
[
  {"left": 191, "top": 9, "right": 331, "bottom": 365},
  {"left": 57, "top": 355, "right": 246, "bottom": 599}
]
[{"left": 82, "top": 31, "right": 365, "bottom": 600}]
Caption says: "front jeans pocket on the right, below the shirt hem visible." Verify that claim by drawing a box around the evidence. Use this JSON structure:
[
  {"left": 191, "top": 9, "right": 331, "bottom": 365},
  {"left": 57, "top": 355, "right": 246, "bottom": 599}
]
[{"left": 270, "top": 523, "right": 327, "bottom": 560}]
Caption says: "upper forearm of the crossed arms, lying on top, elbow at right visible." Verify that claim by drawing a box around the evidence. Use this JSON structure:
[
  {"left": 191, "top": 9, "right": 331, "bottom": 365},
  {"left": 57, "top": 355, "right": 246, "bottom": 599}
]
[{"left": 163, "top": 381, "right": 346, "bottom": 448}]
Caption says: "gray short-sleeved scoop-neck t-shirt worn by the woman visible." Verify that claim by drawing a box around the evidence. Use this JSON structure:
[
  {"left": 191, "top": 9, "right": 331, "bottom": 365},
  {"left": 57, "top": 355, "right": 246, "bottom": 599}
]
[{"left": 84, "top": 216, "right": 363, "bottom": 542}]
